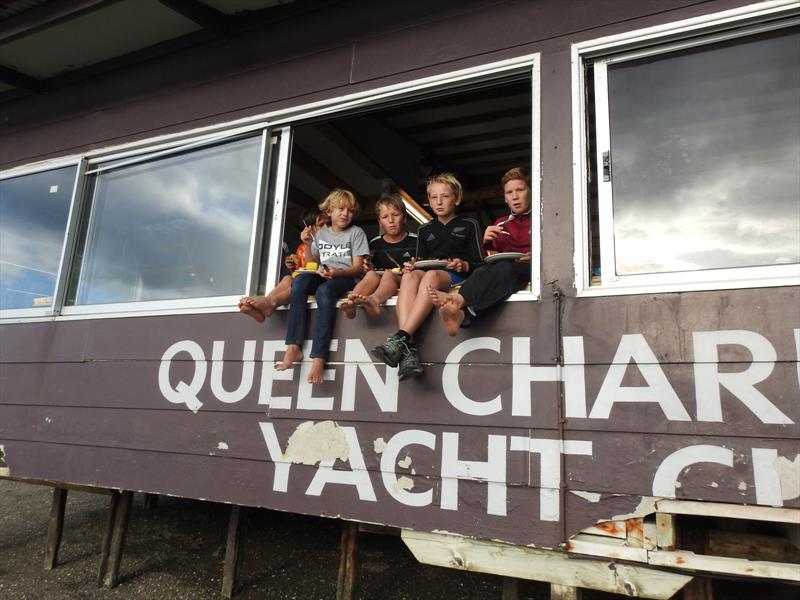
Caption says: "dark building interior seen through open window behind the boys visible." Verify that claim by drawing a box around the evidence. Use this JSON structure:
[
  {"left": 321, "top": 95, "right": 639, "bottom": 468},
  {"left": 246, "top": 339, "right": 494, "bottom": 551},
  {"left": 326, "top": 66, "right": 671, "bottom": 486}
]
[{"left": 270, "top": 76, "right": 538, "bottom": 292}]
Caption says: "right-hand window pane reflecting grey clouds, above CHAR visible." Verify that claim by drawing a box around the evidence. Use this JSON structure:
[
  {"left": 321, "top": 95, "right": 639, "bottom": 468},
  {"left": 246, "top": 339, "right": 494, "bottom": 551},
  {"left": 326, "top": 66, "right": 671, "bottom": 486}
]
[{"left": 608, "top": 28, "right": 800, "bottom": 275}]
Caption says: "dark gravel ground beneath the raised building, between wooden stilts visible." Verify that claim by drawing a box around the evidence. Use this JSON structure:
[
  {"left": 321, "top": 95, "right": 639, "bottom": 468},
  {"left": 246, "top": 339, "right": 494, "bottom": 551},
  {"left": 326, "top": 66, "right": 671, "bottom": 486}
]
[{"left": 0, "top": 480, "right": 798, "bottom": 600}]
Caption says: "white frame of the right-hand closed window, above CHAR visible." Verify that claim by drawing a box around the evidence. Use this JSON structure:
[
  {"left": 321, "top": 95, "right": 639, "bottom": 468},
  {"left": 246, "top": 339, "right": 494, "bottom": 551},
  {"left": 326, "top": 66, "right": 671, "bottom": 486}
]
[{"left": 572, "top": 0, "right": 800, "bottom": 296}]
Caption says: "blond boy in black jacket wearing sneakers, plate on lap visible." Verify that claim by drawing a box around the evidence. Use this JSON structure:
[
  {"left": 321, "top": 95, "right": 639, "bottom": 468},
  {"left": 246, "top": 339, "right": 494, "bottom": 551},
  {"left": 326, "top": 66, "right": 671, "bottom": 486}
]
[{"left": 372, "top": 173, "right": 482, "bottom": 380}]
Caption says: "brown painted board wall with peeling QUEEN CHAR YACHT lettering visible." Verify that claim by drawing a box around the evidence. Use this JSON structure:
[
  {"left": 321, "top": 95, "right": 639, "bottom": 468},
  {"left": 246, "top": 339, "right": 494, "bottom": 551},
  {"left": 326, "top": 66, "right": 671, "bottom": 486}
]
[{"left": 0, "top": 0, "right": 800, "bottom": 546}]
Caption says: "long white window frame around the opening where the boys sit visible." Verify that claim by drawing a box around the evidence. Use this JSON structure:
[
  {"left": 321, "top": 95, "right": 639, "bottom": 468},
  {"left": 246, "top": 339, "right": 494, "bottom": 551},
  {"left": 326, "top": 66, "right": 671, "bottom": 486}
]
[{"left": 0, "top": 53, "right": 542, "bottom": 322}]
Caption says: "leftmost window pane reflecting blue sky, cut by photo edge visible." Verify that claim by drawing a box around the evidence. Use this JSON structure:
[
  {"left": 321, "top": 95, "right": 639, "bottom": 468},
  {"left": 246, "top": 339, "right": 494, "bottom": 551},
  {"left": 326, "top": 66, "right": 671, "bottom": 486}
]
[{"left": 0, "top": 165, "right": 76, "bottom": 309}]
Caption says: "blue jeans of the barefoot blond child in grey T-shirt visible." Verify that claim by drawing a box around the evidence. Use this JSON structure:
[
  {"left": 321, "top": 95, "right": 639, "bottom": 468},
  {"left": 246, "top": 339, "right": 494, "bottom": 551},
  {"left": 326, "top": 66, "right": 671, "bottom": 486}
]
[{"left": 286, "top": 275, "right": 356, "bottom": 360}]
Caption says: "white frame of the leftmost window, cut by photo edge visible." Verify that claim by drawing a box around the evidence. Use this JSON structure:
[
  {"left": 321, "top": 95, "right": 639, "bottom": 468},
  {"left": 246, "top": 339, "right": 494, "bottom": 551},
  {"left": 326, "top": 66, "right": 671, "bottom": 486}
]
[{"left": 0, "top": 156, "right": 86, "bottom": 320}]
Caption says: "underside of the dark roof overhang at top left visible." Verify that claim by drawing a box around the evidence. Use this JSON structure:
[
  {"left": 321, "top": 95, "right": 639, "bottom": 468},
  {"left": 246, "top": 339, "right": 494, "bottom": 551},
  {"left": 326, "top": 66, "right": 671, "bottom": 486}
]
[{"left": 0, "top": 0, "right": 302, "bottom": 101}]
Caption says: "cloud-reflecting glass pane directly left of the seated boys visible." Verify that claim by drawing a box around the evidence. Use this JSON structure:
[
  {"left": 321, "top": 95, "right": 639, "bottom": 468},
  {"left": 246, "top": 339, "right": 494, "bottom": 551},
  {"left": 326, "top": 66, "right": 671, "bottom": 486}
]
[{"left": 74, "top": 136, "right": 261, "bottom": 304}]
